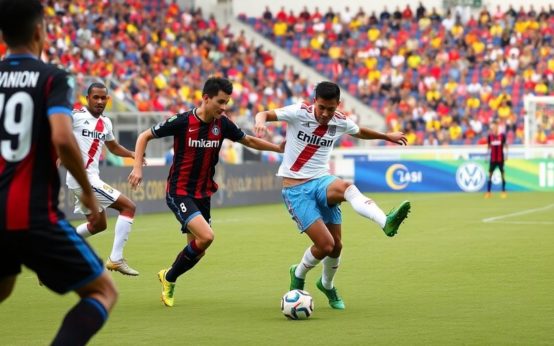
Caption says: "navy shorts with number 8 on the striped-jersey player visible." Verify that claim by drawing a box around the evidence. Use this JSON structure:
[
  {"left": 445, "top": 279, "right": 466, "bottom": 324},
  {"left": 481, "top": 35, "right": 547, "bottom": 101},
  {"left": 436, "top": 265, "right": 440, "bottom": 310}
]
[{"left": 165, "top": 194, "right": 212, "bottom": 233}]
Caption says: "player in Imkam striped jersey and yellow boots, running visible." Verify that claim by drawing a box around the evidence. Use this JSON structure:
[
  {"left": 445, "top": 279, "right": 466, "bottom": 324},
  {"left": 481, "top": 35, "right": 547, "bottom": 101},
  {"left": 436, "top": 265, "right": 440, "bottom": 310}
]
[{"left": 129, "top": 78, "right": 283, "bottom": 306}]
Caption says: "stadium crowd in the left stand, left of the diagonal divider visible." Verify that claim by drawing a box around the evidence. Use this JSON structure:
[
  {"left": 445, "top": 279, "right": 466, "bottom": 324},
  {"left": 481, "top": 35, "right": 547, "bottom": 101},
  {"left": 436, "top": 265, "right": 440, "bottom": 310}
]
[{"left": 0, "top": 0, "right": 328, "bottom": 147}]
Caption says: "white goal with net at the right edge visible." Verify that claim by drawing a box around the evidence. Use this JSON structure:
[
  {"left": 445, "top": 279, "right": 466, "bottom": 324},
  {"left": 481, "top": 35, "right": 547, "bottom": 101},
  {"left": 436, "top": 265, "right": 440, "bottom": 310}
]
[{"left": 523, "top": 96, "right": 554, "bottom": 146}]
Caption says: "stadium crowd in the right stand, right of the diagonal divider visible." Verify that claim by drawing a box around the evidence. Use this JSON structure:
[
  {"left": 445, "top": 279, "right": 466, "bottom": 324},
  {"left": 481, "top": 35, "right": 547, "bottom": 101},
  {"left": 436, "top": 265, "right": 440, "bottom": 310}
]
[{"left": 244, "top": 3, "right": 554, "bottom": 145}]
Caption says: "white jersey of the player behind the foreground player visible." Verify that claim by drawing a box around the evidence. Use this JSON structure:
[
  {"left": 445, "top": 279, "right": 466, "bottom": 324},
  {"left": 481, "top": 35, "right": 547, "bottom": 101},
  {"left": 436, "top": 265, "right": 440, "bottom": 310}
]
[{"left": 66, "top": 107, "right": 115, "bottom": 189}]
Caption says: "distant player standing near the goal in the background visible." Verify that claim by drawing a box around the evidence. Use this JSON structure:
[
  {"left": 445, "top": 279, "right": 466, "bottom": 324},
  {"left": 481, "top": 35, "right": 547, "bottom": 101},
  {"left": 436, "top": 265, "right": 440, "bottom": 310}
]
[{"left": 485, "top": 121, "right": 508, "bottom": 198}]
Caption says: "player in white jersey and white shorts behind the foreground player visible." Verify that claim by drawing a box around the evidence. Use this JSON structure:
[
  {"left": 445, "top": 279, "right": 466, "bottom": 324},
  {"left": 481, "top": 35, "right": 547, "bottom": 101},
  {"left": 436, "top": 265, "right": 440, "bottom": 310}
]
[{"left": 66, "top": 83, "right": 139, "bottom": 276}]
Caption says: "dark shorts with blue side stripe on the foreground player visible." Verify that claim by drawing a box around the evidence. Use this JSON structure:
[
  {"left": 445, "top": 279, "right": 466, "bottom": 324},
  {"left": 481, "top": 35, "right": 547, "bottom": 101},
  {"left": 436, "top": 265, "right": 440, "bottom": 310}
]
[{"left": 0, "top": 220, "right": 104, "bottom": 294}]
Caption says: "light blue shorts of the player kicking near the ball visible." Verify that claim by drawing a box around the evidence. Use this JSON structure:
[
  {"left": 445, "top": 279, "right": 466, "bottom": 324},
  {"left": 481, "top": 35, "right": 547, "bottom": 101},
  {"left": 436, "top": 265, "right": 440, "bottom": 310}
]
[{"left": 282, "top": 175, "right": 342, "bottom": 232}]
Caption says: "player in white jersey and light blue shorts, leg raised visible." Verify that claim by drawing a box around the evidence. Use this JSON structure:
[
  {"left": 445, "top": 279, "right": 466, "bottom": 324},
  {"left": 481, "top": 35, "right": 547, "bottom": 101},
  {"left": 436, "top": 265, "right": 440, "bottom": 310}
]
[{"left": 254, "top": 82, "right": 410, "bottom": 309}]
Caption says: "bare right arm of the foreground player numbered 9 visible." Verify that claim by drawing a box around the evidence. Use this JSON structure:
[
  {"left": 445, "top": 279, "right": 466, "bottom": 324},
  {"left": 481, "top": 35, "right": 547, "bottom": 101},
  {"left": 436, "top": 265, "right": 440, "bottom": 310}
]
[{"left": 48, "top": 114, "right": 100, "bottom": 222}]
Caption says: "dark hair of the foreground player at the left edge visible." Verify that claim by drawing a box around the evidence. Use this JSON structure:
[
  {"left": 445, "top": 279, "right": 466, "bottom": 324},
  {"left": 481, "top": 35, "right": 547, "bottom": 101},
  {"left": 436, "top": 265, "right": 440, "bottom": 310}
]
[{"left": 0, "top": 0, "right": 44, "bottom": 47}]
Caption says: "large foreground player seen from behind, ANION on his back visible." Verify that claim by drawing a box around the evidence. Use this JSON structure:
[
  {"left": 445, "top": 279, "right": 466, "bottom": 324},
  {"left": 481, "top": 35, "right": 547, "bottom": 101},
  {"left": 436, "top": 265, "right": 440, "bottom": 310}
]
[{"left": 0, "top": 0, "right": 117, "bottom": 346}]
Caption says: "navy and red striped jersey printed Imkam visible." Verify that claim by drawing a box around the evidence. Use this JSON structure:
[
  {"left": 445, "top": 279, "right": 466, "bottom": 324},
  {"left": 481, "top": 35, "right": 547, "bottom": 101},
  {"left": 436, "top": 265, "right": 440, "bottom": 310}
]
[{"left": 151, "top": 108, "right": 245, "bottom": 198}]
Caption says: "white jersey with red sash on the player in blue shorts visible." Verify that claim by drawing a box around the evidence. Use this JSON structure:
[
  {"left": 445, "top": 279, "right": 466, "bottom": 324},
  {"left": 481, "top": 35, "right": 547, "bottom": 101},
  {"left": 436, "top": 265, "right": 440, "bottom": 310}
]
[{"left": 275, "top": 103, "right": 360, "bottom": 179}]
